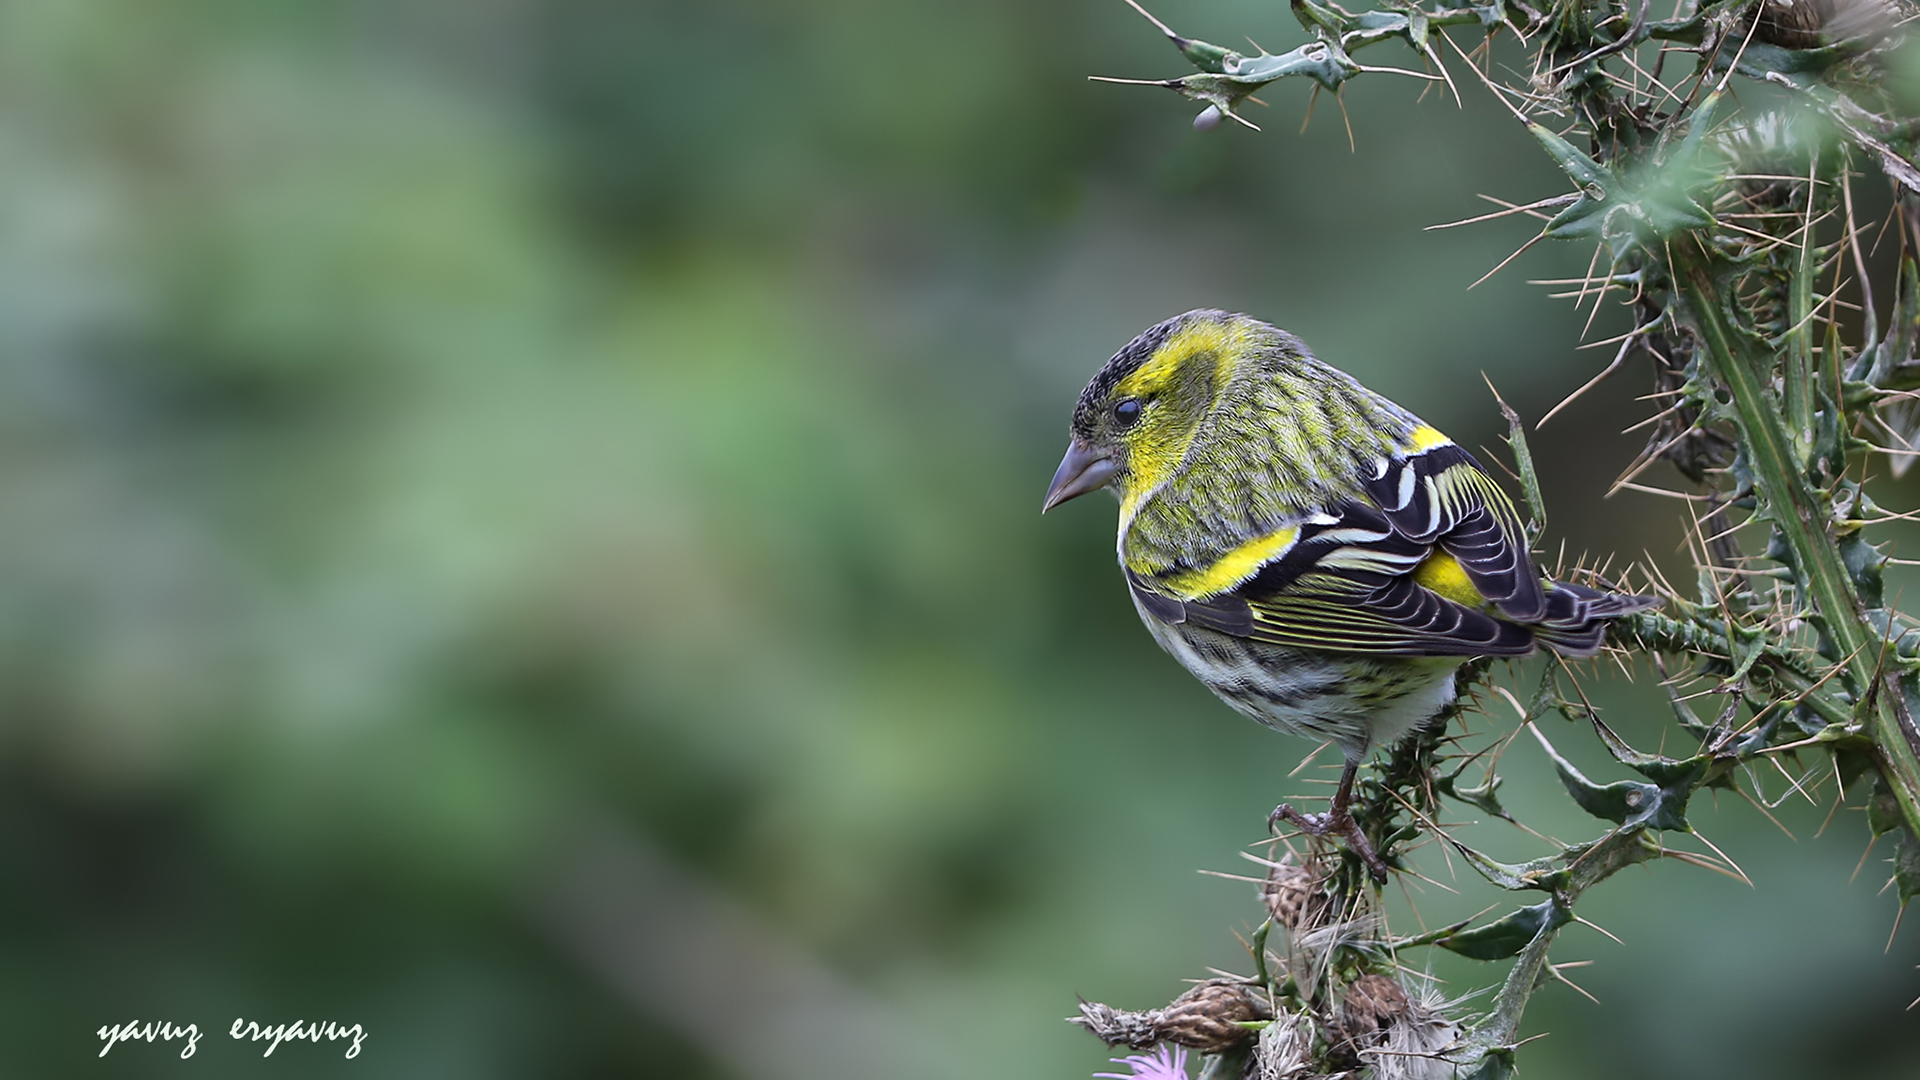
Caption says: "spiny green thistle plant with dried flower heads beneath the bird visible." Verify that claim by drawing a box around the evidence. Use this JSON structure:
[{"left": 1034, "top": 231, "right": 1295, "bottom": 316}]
[{"left": 1075, "top": 0, "right": 1920, "bottom": 1080}]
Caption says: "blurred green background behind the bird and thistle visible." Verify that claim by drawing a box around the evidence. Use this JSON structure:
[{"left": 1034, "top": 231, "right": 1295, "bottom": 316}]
[{"left": 0, "top": 0, "right": 1920, "bottom": 1080}]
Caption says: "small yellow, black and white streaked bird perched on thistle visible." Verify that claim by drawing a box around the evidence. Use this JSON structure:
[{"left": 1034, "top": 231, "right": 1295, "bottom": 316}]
[{"left": 1041, "top": 311, "right": 1659, "bottom": 882}]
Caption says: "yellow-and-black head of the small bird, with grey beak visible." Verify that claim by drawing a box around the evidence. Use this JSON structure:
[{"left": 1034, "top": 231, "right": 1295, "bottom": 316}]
[{"left": 1041, "top": 311, "right": 1275, "bottom": 513}]
